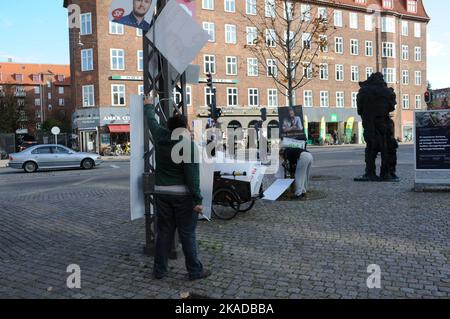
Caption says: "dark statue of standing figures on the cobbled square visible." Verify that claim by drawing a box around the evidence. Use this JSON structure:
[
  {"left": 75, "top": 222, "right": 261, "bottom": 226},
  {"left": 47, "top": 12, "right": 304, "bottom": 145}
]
[{"left": 355, "top": 72, "right": 399, "bottom": 182}]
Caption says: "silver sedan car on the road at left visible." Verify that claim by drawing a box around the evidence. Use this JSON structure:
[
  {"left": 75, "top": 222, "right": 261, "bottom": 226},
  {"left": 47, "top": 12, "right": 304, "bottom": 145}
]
[{"left": 8, "top": 144, "right": 102, "bottom": 173}]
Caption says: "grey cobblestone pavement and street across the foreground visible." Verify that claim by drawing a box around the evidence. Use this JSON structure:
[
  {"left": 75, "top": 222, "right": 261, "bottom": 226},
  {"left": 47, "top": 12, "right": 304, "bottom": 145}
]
[{"left": 0, "top": 146, "right": 450, "bottom": 298}]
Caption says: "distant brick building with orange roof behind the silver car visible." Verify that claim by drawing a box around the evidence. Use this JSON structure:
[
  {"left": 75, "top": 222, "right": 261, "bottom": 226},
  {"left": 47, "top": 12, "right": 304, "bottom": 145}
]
[{"left": 0, "top": 62, "right": 73, "bottom": 135}]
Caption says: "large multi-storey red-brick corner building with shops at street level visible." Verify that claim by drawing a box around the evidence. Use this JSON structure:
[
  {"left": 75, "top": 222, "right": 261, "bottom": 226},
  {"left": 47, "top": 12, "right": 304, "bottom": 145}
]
[{"left": 64, "top": 0, "right": 429, "bottom": 151}]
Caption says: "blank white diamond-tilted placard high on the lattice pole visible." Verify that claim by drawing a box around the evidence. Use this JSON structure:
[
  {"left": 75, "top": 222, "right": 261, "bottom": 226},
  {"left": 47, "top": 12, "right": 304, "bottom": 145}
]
[{"left": 147, "top": 1, "right": 209, "bottom": 74}]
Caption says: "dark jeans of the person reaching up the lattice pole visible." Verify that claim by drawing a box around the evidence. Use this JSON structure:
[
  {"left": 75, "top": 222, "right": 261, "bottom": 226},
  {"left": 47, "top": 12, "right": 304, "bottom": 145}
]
[{"left": 154, "top": 195, "right": 203, "bottom": 278}]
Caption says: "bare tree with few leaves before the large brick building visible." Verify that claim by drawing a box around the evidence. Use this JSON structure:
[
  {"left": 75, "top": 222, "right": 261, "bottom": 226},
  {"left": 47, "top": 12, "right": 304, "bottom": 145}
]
[{"left": 242, "top": 0, "right": 335, "bottom": 106}]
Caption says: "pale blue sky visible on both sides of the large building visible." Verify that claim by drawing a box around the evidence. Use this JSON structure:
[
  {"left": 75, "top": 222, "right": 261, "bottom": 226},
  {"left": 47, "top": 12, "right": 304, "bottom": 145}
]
[{"left": 0, "top": 0, "right": 450, "bottom": 88}]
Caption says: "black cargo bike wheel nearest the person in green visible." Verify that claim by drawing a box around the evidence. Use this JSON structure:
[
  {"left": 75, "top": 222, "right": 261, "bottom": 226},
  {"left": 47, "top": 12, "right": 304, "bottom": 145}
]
[{"left": 212, "top": 188, "right": 241, "bottom": 220}]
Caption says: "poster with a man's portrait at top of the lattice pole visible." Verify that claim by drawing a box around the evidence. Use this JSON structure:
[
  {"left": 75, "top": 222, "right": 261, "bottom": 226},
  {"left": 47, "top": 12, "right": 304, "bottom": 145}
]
[{"left": 109, "top": 0, "right": 157, "bottom": 31}]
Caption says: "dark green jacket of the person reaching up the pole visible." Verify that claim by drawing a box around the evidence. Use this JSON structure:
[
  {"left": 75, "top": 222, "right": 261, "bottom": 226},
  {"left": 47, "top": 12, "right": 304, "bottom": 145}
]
[{"left": 144, "top": 104, "right": 203, "bottom": 205}]
